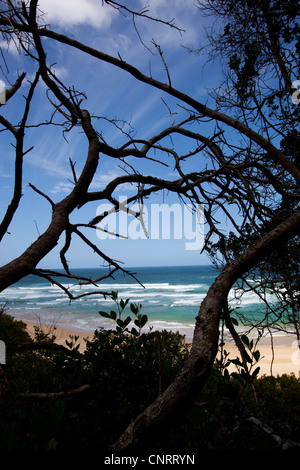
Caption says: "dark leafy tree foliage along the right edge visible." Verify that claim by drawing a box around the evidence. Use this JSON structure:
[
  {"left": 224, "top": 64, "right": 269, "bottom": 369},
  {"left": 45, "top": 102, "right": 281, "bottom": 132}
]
[{"left": 198, "top": 1, "right": 299, "bottom": 346}]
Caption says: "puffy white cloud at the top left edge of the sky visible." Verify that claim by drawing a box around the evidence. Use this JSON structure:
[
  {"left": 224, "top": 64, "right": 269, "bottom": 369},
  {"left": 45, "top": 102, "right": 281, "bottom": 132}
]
[{"left": 39, "top": 0, "right": 114, "bottom": 28}]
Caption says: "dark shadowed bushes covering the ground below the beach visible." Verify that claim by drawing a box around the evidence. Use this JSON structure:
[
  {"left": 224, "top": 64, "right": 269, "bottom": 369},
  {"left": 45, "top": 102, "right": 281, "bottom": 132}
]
[{"left": 0, "top": 308, "right": 300, "bottom": 456}]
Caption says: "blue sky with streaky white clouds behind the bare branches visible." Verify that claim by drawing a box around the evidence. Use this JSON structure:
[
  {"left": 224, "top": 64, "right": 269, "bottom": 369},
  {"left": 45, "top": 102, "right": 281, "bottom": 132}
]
[{"left": 0, "top": 0, "right": 226, "bottom": 269}]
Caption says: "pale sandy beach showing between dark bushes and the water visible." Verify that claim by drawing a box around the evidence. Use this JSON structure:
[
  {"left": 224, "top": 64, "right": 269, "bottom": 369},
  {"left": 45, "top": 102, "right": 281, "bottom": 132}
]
[{"left": 24, "top": 321, "right": 300, "bottom": 377}]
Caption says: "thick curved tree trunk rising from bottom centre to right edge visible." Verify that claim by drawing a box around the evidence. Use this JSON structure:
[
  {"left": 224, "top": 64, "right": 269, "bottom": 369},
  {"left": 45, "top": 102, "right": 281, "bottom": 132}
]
[{"left": 112, "top": 212, "right": 300, "bottom": 451}]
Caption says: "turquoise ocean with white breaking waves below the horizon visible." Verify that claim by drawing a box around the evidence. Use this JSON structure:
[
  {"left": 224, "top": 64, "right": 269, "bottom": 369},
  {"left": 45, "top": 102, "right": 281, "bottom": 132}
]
[{"left": 0, "top": 266, "right": 278, "bottom": 341}]
